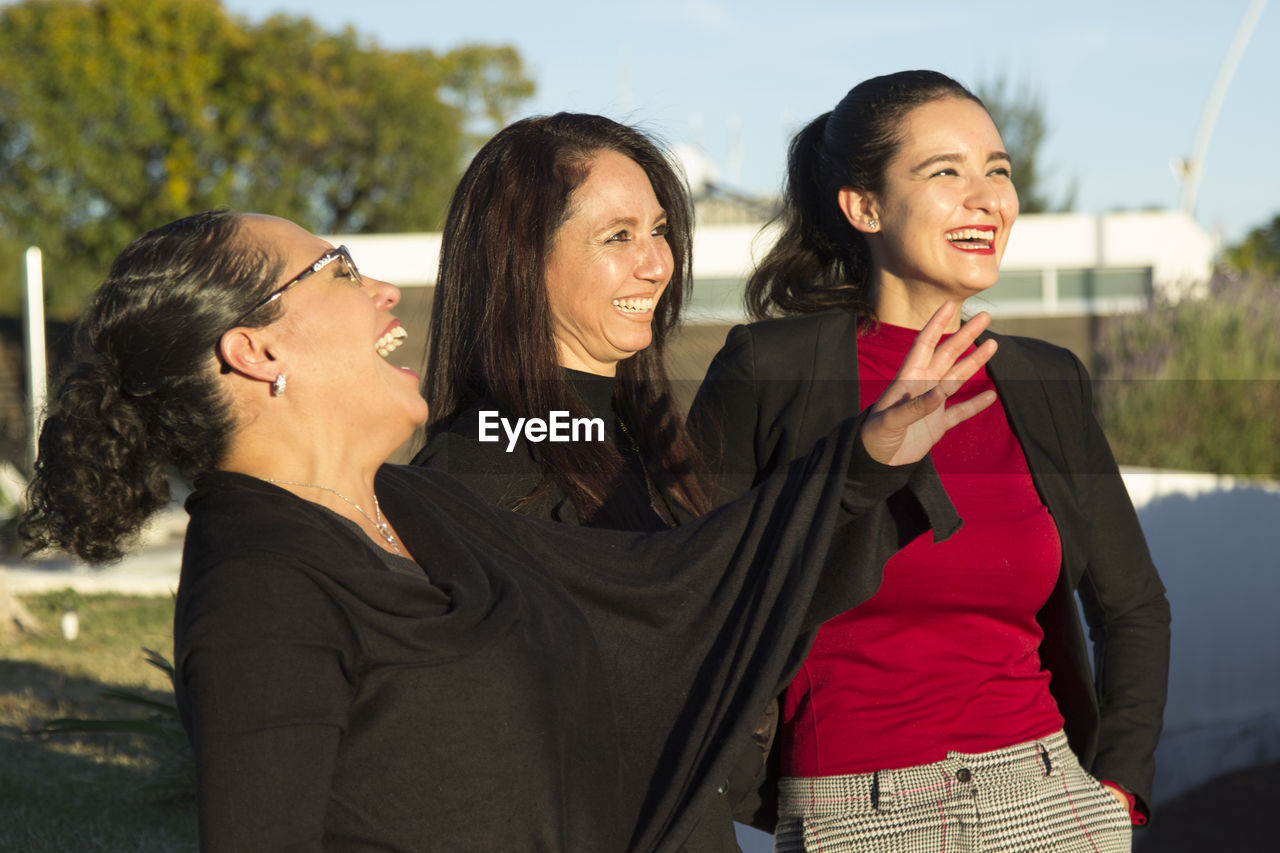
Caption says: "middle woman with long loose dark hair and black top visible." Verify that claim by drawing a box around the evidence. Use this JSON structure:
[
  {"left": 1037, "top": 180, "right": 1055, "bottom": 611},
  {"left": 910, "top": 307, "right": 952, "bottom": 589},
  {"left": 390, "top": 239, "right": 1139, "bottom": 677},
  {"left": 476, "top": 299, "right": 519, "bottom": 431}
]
[{"left": 415, "top": 113, "right": 747, "bottom": 853}]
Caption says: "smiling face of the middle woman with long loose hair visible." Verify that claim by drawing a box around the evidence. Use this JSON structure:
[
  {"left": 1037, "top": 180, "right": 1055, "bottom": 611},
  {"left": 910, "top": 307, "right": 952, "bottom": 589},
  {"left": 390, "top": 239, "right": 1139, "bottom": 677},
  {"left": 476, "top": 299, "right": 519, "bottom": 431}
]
[{"left": 547, "top": 151, "right": 673, "bottom": 377}]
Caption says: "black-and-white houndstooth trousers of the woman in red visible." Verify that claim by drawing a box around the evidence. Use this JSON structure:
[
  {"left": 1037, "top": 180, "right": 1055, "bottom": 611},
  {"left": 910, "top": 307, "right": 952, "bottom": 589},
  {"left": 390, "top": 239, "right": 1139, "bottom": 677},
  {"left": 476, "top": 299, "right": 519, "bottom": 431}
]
[{"left": 773, "top": 731, "right": 1133, "bottom": 853}]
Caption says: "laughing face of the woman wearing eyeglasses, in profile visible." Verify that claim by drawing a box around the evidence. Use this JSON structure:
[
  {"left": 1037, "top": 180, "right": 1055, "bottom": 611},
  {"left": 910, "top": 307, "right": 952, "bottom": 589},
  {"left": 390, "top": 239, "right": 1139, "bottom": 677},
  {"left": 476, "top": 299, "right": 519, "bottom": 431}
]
[{"left": 244, "top": 215, "right": 428, "bottom": 429}]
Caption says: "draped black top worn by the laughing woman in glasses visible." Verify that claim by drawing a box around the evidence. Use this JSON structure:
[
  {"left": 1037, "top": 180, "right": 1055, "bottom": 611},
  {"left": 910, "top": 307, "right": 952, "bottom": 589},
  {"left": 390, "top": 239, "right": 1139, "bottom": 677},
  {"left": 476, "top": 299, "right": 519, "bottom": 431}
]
[{"left": 174, "top": 425, "right": 957, "bottom": 852}]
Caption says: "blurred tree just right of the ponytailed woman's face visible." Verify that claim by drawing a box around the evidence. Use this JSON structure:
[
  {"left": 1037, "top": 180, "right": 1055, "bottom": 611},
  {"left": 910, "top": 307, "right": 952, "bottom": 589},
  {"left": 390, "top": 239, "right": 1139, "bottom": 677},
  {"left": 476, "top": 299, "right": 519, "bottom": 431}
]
[{"left": 975, "top": 76, "right": 1075, "bottom": 213}]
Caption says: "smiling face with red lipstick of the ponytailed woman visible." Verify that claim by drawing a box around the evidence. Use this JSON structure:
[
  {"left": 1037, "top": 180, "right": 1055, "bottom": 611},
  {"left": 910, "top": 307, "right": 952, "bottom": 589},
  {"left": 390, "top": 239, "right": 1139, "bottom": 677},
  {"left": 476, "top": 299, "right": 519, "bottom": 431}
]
[{"left": 845, "top": 97, "right": 1018, "bottom": 318}]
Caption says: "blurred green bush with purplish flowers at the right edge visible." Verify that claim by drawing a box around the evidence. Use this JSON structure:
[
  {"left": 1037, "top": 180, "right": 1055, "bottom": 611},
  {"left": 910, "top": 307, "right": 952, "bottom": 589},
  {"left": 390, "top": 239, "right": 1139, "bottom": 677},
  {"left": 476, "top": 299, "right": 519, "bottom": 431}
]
[{"left": 1097, "top": 274, "right": 1280, "bottom": 478}]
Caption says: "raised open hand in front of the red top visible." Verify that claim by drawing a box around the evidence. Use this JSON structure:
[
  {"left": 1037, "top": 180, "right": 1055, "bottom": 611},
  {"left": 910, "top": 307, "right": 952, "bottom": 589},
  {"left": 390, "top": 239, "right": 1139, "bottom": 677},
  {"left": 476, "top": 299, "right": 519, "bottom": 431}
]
[{"left": 861, "top": 301, "right": 996, "bottom": 465}]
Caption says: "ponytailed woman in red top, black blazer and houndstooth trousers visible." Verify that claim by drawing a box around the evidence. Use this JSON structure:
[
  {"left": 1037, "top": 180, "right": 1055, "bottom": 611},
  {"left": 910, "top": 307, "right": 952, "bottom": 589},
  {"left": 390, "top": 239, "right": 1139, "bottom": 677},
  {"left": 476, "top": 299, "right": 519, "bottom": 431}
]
[{"left": 690, "top": 72, "right": 1169, "bottom": 853}]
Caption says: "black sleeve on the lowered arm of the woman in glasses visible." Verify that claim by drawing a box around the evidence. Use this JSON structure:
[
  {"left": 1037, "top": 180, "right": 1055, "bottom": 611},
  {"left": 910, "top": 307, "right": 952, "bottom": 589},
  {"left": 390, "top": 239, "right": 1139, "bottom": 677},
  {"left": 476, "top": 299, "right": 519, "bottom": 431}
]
[{"left": 174, "top": 556, "right": 352, "bottom": 853}]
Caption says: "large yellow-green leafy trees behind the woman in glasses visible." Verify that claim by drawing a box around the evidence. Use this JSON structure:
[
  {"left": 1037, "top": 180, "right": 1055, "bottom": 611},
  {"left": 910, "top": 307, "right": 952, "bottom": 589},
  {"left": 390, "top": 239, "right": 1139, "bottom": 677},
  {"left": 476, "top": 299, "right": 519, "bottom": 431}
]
[{"left": 0, "top": 0, "right": 532, "bottom": 316}]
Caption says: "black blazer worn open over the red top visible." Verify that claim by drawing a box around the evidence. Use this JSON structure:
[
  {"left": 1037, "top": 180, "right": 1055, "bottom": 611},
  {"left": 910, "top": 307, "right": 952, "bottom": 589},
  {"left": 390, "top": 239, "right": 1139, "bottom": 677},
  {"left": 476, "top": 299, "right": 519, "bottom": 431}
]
[{"left": 689, "top": 309, "right": 1169, "bottom": 809}]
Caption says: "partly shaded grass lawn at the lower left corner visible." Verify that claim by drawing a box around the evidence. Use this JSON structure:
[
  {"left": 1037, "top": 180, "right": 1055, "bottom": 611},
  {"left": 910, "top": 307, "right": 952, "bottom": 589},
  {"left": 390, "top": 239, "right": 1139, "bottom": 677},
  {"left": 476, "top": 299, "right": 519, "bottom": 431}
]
[{"left": 0, "top": 590, "right": 197, "bottom": 853}]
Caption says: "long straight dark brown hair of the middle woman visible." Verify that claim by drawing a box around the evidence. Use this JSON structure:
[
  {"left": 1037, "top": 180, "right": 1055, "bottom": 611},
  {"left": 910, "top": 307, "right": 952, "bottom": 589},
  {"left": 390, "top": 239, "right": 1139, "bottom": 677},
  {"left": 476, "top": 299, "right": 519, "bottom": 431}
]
[{"left": 422, "top": 113, "right": 709, "bottom": 519}]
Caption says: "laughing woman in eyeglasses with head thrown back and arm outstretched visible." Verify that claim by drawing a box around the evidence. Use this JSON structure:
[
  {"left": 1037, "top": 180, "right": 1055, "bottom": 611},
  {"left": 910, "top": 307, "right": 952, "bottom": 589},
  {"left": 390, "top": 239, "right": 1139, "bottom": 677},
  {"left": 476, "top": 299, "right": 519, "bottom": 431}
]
[{"left": 20, "top": 211, "right": 991, "bottom": 853}]
